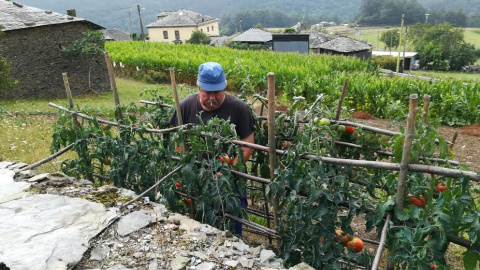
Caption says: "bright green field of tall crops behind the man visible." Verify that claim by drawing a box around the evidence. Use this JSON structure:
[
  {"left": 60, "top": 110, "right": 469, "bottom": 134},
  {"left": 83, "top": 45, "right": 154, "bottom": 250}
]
[{"left": 106, "top": 42, "right": 480, "bottom": 125}]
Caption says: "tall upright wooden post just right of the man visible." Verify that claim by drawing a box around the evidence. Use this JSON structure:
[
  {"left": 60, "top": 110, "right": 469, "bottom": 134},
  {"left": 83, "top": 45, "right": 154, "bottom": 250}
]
[{"left": 267, "top": 72, "right": 279, "bottom": 232}]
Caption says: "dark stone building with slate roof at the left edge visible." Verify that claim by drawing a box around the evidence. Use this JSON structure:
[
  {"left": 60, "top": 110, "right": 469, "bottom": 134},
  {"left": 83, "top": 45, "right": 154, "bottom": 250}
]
[{"left": 0, "top": 1, "right": 110, "bottom": 98}]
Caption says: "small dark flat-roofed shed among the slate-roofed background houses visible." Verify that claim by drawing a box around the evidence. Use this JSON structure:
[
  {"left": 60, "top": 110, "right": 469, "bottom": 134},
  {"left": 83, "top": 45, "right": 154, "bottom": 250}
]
[{"left": 272, "top": 34, "right": 309, "bottom": 54}]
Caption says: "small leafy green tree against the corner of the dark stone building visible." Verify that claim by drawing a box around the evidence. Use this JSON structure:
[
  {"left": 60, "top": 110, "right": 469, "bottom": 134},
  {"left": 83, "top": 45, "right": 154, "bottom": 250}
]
[{"left": 62, "top": 30, "right": 105, "bottom": 90}]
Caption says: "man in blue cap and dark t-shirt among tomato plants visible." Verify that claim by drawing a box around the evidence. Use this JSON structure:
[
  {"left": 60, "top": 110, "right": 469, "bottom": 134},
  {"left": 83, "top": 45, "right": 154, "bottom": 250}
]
[{"left": 170, "top": 62, "right": 255, "bottom": 235}]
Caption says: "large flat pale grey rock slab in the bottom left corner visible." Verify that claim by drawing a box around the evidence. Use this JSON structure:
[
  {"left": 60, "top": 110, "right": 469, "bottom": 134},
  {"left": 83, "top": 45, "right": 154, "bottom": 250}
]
[{"left": 0, "top": 194, "right": 115, "bottom": 269}]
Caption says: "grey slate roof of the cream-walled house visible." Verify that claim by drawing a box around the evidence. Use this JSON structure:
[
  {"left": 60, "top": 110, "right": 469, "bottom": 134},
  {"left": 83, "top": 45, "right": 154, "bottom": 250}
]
[{"left": 147, "top": 9, "right": 218, "bottom": 28}]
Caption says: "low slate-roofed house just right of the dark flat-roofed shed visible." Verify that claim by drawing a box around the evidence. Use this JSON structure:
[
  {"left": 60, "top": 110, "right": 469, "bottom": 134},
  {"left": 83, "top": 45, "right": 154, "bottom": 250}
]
[{"left": 310, "top": 37, "right": 372, "bottom": 59}]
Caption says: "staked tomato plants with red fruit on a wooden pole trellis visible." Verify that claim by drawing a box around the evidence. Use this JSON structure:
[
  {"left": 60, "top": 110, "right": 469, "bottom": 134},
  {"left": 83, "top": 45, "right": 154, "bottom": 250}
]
[{"left": 45, "top": 51, "right": 480, "bottom": 269}]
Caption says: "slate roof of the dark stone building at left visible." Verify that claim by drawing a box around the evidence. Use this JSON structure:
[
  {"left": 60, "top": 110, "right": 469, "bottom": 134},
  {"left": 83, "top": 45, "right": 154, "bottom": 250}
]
[{"left": 0, "top": 0, "right": 103, "bottom": 32}]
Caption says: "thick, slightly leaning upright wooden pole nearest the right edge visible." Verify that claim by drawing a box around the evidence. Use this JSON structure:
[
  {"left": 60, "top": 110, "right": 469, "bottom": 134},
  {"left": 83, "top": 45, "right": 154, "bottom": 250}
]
[{"left": 395, "top": 94, "right": 418, "bottom": 211}]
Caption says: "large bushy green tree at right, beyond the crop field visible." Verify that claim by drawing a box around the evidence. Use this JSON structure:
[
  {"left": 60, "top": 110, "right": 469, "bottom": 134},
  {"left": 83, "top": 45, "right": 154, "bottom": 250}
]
[{"left": 409, "top": 23, "right": 477, "bottom": 70}]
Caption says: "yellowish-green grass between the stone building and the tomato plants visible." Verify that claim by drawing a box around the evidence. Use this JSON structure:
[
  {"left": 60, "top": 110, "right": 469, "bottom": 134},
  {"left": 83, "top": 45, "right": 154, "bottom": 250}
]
[{"left": 0, "top": 78, "right": 167, "bottom": 172}]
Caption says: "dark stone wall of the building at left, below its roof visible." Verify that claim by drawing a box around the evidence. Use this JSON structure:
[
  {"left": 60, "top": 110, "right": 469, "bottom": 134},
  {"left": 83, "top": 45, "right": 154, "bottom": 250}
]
[{"left": 0, "top": 22, "right": 110, "bottom": 99}]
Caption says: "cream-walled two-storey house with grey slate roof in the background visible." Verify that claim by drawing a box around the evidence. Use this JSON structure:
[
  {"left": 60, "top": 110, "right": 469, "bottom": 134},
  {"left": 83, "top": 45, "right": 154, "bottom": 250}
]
[{"left": 147, "top": 9, "right": 220, "bottom": 43}]
